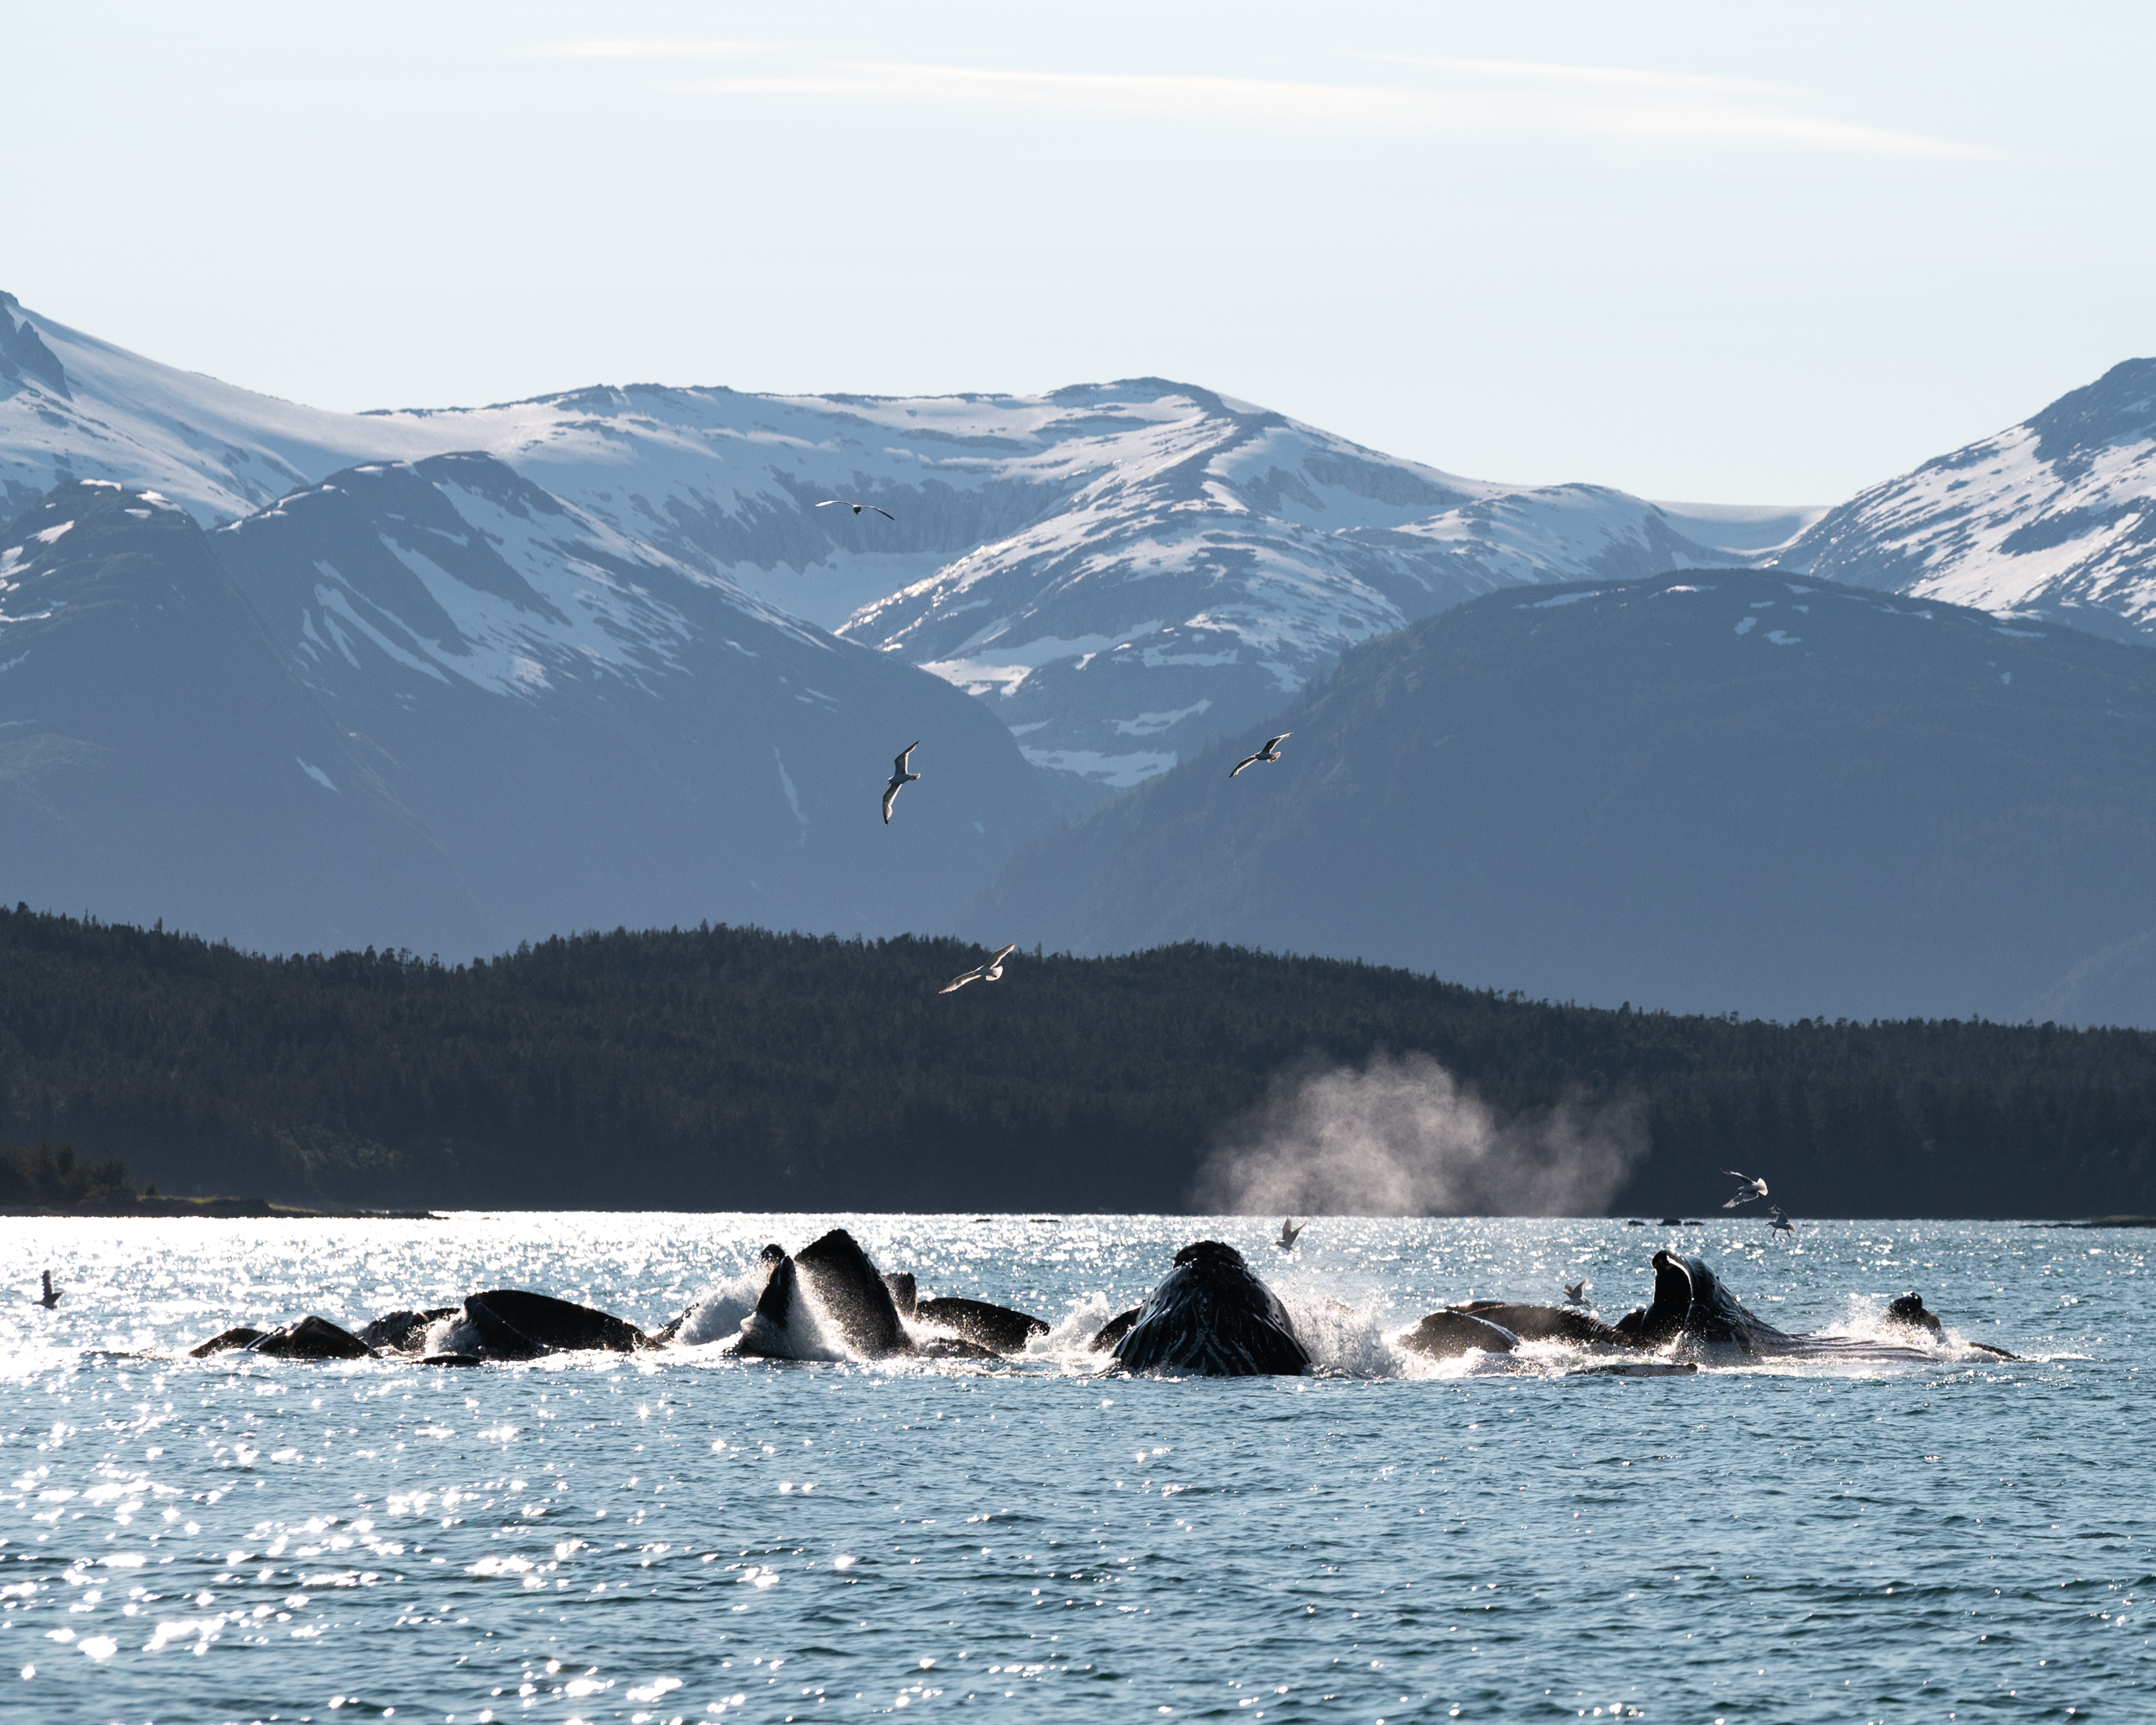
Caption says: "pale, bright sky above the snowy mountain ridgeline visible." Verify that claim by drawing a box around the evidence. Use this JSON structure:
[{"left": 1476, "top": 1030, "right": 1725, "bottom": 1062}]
[{"left": 0, "top": 0, "right": 2156, "bottom": 505}]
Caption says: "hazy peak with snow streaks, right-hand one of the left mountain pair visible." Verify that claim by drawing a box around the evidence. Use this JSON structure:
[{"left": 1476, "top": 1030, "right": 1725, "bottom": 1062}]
[{"left": 210, "top": 455, "right": 1055, "bottom": 938}]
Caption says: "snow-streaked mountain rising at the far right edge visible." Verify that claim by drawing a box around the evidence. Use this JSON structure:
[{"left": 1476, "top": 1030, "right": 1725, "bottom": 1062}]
[{"left": 1775, "top": 361, "right": 2156, "bottom": 643}]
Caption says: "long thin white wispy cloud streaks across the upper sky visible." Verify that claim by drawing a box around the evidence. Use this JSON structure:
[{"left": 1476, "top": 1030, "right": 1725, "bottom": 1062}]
[{"left": 517, "top": 39, "right": 1999, "bottom": 160}]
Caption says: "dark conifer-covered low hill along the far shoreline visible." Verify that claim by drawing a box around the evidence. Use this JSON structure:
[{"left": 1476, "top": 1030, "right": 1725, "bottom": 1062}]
[{"left": 0, "top": 908, "right": 2156, "bottom": 1219}]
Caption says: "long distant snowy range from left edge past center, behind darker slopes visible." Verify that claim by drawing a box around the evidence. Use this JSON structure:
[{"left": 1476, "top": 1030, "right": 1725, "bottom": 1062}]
[{"left": 0, "top": 289, "right": 1805, "bottom": 792}]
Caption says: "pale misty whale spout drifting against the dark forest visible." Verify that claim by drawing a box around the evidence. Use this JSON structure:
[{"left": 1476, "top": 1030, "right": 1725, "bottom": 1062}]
[{"left": 1194, "top": 1055, "right": 1647, "bottom": 1216}]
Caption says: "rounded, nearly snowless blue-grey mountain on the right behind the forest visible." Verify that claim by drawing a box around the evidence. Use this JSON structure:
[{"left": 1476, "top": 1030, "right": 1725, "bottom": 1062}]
[{"left": 968, "top": 569, "right": 2156, "bottom": 1025}]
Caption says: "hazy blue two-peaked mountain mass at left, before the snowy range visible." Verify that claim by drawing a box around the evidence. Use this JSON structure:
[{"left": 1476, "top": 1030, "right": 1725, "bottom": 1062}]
[{"left": 0, "top": 467, "right": 1052, "bottom": 957}]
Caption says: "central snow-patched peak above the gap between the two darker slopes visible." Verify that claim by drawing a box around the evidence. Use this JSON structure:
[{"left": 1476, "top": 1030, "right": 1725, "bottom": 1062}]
[{"left": 841, "top": 394, "right": 1732, "bottom": 787}]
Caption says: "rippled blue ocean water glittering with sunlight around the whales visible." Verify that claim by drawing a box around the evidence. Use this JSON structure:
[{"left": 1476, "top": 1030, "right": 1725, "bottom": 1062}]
[{"left": 0, "top": 1214, "right": 2156, "bottom": 1725}]
